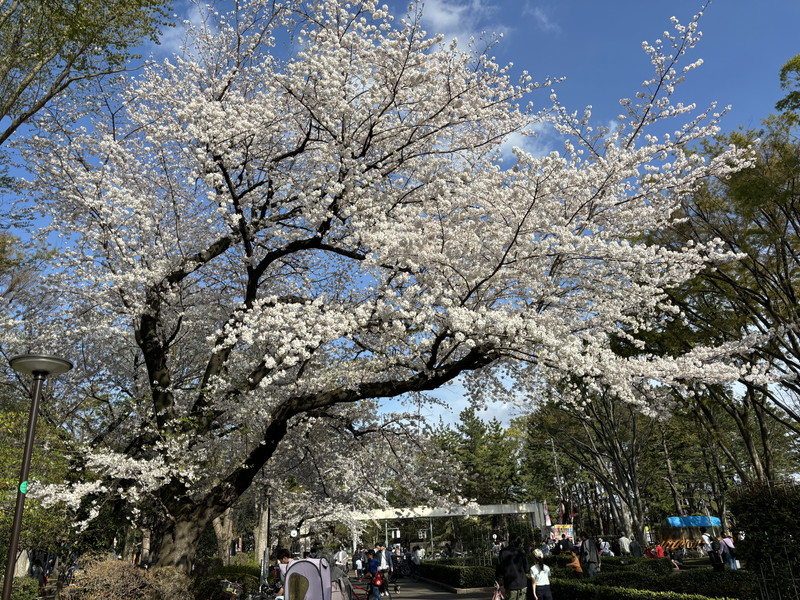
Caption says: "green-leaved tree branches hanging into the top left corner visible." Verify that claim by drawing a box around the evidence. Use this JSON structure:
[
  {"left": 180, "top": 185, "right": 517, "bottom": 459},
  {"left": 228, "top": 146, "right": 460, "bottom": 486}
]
[{"left": 0, "top": 0, "right": 169, "bottom": 145}]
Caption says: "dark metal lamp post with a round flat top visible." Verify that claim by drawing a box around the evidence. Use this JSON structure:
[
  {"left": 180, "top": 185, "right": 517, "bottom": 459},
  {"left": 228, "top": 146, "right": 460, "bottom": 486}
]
[{"left": 2, "top": 354, "right": 72, "bottom": 600}]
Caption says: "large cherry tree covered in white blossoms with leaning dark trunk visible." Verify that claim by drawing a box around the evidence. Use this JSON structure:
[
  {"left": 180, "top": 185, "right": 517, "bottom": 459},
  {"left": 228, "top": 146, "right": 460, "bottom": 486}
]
[{"left": 15, "top": 0, "right": 755, "bottom": 568}]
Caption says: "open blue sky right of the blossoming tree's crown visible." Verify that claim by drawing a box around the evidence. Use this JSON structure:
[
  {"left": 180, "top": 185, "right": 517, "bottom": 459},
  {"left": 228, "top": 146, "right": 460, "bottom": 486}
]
[{"left": 406, "top": 0, "right": 800, "bottom": 134}]
